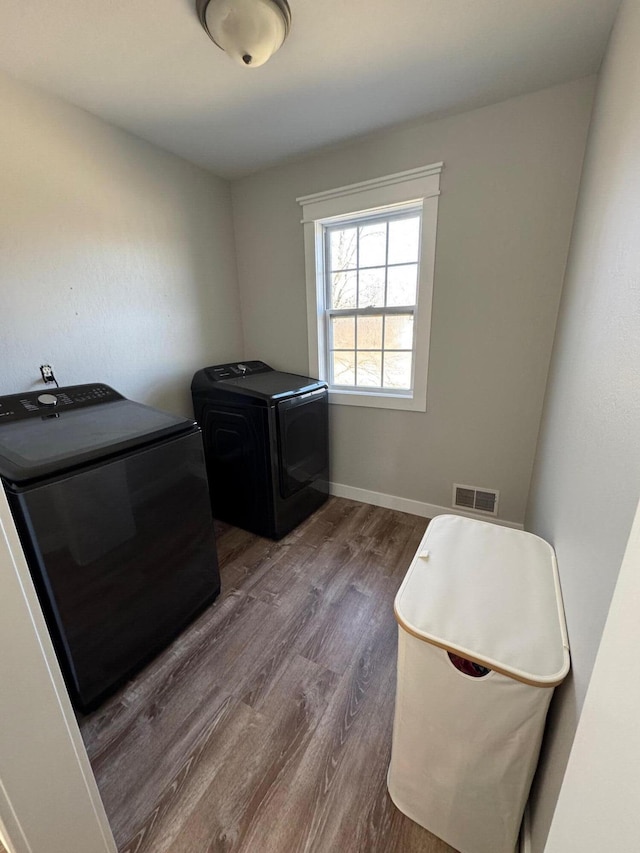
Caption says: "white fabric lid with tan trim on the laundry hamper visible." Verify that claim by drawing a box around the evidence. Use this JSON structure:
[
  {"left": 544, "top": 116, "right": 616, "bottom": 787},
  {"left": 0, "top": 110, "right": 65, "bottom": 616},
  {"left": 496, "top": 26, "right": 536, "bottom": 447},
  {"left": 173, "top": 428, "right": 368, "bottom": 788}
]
[{"left": 395, "top": 515, "right": 569, "bottom": 687}]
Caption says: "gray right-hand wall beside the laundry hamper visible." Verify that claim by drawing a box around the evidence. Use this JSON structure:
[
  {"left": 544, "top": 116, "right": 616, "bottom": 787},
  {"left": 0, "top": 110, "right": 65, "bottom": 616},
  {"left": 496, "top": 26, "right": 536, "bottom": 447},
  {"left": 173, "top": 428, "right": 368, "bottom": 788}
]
[{"left": 526, "top": 0, "right": 640, "bottom": 853}]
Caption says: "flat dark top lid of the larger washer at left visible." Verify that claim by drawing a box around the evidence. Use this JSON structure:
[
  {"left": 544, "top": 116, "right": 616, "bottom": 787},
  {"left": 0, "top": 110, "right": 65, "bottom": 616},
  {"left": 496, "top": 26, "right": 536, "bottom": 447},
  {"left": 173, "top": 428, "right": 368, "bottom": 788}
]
[{"left": 0, "top": 386, "right": 196, "bottom": 483}]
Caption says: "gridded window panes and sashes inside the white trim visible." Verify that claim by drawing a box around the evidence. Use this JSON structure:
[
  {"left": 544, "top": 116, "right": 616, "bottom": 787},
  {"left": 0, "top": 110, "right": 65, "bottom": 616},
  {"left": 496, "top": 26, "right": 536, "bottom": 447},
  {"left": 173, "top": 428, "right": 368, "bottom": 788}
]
[{"left": 324, "top": 206, "right": 422, "bottom": 394}]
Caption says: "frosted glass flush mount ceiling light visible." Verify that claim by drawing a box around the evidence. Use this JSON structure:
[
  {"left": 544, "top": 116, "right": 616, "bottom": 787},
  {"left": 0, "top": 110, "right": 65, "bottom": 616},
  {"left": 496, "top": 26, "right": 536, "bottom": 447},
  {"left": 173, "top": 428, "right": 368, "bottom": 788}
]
[{"left": 196, "top": 0, "right": 291, "bottom": 68}]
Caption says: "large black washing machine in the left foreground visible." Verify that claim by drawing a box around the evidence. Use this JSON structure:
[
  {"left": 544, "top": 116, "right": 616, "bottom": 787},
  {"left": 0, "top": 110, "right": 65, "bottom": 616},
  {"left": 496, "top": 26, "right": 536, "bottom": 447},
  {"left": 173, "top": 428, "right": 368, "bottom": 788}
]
[{"left": 0, "top": 384, "right": 220, "bottom": 712}]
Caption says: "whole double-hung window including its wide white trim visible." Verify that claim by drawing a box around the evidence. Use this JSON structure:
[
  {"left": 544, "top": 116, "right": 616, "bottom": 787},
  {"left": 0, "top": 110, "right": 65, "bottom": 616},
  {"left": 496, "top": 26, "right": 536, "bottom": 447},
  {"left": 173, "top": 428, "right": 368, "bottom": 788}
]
[{"left": 298, "top": 163, "right": 442, "bottom": 411}]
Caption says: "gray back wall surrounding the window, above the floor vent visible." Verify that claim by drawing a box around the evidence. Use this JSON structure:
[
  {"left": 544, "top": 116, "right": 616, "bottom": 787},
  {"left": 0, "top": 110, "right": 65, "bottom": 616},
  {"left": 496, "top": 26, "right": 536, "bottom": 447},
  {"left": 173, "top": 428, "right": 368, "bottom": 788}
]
[{"left": 232, "top": 78, "right": 594, "bottom": 522}]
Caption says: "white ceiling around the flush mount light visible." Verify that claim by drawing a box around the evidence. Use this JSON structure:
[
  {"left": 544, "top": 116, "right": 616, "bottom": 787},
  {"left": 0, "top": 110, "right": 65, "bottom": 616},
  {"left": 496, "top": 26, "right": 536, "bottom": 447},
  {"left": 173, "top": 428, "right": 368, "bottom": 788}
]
[{"left": 0, "top": 0, "right": 619, "bottom": 177}]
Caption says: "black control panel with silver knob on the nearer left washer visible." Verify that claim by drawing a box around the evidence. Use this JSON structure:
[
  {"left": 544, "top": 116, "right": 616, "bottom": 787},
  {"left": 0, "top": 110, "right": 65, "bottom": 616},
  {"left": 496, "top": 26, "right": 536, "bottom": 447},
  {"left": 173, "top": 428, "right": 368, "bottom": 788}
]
[{"left": 0, "top": 383, "right": 125, "bottom": 426}]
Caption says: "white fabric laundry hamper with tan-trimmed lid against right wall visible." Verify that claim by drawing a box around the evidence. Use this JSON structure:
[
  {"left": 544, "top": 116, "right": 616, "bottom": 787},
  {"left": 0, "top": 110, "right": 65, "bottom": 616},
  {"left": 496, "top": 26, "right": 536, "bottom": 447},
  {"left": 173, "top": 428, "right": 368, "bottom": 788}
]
[{"left": 388, "top": 515, "right": 569, "bottom": 853}]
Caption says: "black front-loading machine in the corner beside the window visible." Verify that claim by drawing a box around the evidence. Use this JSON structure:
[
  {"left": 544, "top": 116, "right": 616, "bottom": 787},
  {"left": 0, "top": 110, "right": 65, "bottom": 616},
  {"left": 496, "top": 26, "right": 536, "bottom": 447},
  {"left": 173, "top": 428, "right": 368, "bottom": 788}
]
[{"left": 191, "top": 361, "right": 329, "bottom": 539}]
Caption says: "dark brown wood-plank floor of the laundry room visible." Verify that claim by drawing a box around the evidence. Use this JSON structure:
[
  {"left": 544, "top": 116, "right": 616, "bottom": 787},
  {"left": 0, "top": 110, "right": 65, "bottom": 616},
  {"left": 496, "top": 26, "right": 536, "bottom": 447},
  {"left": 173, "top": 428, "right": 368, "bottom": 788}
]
[{"left": 81, "top": 498, "right": 455, "bottom": 853}]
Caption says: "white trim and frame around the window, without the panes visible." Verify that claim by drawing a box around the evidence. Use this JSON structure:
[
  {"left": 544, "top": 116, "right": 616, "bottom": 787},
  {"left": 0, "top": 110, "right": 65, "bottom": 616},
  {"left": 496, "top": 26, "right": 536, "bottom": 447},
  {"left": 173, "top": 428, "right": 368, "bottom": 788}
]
[{"left": 297, "top": 163, "right": 443, "bottom": 412}]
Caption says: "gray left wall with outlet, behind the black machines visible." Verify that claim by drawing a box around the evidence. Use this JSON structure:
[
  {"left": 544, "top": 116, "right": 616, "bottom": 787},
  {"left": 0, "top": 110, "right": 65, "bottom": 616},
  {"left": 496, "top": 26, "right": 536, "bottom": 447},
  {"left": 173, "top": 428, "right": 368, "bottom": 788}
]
[{"left": 0, "top": 70, "right": 242, "bottom": 414}]
